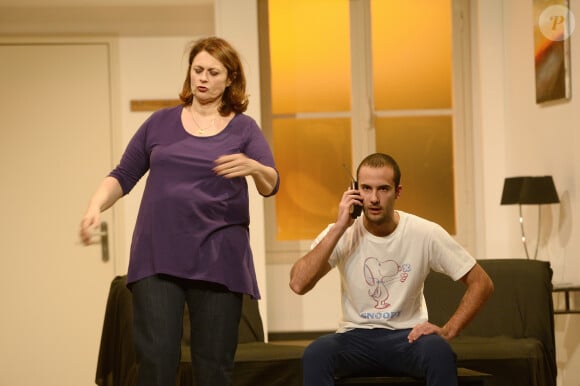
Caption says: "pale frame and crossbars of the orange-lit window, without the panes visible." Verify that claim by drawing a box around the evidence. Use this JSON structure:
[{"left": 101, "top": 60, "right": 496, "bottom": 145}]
[{"left": 258, "top": 0, "right": 476, "bottom": 264}]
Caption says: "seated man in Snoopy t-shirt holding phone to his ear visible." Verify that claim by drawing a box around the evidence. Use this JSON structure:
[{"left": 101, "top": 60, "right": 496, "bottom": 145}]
[{"left": 290, "top": 153, "right": 493, "bottom": 386}]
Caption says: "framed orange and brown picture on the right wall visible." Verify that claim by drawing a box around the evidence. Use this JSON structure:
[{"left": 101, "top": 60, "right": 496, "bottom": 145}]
[{"left": 533, "top": 0, "right": 575, "bottom": 104}]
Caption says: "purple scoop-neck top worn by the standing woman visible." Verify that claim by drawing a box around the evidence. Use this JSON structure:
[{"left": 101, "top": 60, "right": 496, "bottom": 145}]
[{"left": 110, "top": 106, "right": 280, "bottom": 299}]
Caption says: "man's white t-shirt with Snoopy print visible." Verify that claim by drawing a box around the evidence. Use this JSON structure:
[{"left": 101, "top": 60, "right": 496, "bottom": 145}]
[{"left": 312, "top": 211, "right": 476, "bottom": 332}]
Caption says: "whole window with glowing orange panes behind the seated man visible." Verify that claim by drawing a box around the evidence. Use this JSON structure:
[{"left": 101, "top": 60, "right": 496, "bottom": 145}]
[{"left": 260, "top": 0, "right": 472, "bottom": 263}]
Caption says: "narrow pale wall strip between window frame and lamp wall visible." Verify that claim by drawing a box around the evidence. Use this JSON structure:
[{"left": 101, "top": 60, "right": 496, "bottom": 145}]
[{"left": 471, "top": 0, "right": 510, "bottom": 257}]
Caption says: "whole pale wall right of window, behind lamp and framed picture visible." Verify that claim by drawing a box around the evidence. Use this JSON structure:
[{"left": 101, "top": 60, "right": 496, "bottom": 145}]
[{"left": 472, "top": 0, "right": 580, "bottom": 386}]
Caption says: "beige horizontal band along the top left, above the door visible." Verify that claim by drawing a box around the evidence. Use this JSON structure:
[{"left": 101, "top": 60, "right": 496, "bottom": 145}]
[{"left": 0, "top": 0, "right": 214, "bottom": 36}]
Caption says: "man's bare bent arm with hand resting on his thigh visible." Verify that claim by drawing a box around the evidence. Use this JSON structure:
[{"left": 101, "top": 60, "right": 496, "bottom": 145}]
[{"left": 409, "top": 263, "right": 494, "bottom": 342}]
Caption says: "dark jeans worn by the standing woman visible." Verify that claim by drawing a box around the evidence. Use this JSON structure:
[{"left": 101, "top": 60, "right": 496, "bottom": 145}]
[{"left": 131, "top": 275, "right": 242, "bottom": 386}]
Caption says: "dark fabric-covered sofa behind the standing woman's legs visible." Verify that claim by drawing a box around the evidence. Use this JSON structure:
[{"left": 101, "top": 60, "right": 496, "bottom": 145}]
[{"left": 95, "top": 276, "right": 304, "bottom": 386}]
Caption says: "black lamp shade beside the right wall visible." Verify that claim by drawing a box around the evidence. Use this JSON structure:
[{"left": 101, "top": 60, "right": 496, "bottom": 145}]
[{"left": 501, "top": 176, "right": 560, "bottom": 205}]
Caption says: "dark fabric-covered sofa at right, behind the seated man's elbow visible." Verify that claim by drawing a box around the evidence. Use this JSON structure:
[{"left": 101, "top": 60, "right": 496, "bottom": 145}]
[{"left": 424, "top": 259, "right": 557, "bottom": 386}]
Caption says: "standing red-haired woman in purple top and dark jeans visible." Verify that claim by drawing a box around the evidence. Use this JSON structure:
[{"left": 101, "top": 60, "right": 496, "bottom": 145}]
[{"left": 80, "top": 37, "right": 280, "bottom": 386}]
